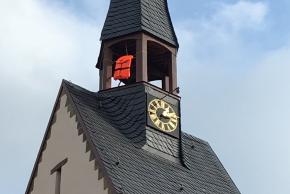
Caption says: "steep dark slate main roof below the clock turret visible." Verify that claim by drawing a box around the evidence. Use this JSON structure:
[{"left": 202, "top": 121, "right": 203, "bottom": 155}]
[{"left": 62, "top": 81, "right": 240, "bottom": 194}]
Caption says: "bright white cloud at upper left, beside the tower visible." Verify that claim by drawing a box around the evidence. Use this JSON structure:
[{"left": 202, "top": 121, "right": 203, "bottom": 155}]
[{"left": 0, "top": 0, "right": 100, "bottom": 88}]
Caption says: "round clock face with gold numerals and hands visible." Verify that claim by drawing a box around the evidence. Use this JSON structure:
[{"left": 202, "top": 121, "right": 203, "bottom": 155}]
[{"left": 148, "top": 99, "right": 179, "bottom": 132}]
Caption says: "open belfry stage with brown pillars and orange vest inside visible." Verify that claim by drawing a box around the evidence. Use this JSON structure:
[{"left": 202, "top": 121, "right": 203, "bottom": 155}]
[{"left": 97, "top": 33, "right": 177, "bottom": 93}]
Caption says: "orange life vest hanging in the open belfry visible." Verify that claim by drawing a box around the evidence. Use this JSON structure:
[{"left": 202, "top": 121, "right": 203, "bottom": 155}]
[{"left": 114, "top": 55, "right": 134, "bottom": 80}]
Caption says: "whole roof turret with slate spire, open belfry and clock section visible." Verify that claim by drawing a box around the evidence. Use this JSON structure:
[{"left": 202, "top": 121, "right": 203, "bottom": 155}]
[{"left": 97, "top": 0, "right": 182, "bottom": 162}]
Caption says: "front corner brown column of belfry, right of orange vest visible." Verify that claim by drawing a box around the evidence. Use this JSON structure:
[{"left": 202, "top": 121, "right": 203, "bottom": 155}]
[{"left": 136, "top": 33, "right": 148, "bottom": 82}]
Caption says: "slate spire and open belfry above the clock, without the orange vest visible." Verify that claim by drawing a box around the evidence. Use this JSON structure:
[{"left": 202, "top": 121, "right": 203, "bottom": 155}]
[{"left": 97, "top": 0, "right": 178, "bottom": 93}]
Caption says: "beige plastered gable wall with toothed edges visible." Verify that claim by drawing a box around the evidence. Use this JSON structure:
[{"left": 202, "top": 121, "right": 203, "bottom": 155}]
[{"left": 31, "top": 95, "right": 108, "bottom": 194}]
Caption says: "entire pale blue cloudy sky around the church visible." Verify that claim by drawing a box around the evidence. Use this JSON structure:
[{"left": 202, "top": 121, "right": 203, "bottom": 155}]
[{"left": 0, "top": 0, "right": 290, "bottom": 194}]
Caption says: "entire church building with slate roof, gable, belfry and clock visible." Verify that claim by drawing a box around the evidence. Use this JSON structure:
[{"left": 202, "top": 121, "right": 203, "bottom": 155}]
[{"left": 25, "top": 0, "right": 240, "bottom": 194}]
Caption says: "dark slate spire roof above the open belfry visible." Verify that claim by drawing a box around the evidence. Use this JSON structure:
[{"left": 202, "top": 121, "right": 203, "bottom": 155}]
[{"left": 101, "top": 0, "right": 178, "bottom": 47}]
